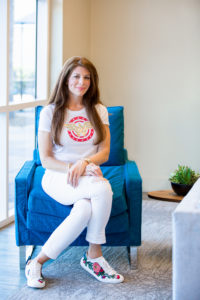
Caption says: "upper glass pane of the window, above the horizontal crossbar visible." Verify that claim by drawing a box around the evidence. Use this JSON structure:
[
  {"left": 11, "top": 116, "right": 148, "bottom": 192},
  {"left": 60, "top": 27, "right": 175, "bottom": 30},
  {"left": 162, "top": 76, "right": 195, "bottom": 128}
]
[{"left": 9, "top": 0, "right": 36, "bottom": 103}]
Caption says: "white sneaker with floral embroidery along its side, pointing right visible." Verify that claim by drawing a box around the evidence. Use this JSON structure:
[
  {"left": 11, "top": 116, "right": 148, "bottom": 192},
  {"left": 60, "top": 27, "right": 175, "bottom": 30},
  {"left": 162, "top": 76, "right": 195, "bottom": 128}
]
[{"left": 80, "top": 253, "right": 124, "bottom": 283}]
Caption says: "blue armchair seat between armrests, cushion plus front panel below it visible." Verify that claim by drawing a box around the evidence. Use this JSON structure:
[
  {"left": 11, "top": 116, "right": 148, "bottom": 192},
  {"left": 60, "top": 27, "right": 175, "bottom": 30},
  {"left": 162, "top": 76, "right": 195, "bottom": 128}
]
[{"left": 27, "top": 166, "right": 129, "bottom": 233}]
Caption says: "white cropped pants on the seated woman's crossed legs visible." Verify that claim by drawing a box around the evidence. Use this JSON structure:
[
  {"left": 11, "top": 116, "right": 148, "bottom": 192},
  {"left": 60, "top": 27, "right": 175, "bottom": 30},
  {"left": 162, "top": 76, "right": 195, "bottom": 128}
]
[{"left": 42, "top": 170, "right": 113, "bottom": 259}]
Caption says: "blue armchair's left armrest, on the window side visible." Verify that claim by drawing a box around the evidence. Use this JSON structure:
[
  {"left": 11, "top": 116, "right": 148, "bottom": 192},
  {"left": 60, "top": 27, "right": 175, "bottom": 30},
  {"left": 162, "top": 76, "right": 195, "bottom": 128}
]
[{"left": 15, "top": 160, "right": 37, "bottom": 246}]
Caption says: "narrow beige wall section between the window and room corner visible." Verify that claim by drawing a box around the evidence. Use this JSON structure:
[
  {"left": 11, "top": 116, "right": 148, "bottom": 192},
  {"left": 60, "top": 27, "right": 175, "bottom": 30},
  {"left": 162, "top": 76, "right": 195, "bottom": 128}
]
[{"left": 50, "top": 0, "right": 90, "bottom": 90}]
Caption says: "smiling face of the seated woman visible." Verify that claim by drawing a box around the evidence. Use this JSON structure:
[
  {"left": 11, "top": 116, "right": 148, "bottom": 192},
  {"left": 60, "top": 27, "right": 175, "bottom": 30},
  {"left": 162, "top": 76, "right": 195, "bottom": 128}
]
[{"left": 68, "top": 67, "right": 90, "bottom": 97}]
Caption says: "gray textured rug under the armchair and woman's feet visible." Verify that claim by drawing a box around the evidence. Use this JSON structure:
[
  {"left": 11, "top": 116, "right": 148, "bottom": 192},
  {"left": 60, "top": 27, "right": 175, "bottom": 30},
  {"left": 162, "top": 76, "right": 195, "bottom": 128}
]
[{"left": 9, "top": 200, "right": 177, "bottom": 300}]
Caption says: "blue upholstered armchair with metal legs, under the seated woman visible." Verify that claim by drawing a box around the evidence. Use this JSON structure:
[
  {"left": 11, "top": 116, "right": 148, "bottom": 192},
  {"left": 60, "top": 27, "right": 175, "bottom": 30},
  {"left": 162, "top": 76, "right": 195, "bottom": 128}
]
[{"left": 15, "top": 106, "right": 142, "bottom": 268}]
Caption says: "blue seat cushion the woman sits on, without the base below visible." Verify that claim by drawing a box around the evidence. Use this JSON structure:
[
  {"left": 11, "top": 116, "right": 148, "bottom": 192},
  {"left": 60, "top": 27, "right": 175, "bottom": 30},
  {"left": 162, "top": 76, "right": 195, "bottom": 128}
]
[{"left": 28, "top": 166, "right": 127, "bottom": 218}]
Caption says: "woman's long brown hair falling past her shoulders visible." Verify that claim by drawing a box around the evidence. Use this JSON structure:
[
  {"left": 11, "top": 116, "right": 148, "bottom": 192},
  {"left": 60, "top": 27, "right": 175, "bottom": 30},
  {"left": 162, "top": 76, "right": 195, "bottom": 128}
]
[{"left": 48, "top": 56, "right": 105, "bottom": 145}]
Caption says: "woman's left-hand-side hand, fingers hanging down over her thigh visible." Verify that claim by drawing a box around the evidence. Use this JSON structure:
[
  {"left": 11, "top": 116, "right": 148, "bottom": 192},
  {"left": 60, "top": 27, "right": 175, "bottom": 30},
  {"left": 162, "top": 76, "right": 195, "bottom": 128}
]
[{"left": 67, "top": 160, "right": 88, "bottom": 188}]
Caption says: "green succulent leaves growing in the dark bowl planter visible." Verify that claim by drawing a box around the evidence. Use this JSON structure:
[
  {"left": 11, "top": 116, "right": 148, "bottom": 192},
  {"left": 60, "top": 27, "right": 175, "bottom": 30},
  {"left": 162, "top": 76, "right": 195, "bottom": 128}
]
[{"left": 169, "top": 165, "right": 200, "bottom": 185}]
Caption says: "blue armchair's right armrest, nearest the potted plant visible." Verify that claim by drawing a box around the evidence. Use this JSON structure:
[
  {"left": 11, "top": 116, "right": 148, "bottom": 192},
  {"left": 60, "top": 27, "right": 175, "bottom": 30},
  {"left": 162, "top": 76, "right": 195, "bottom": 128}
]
[{"left": 125, "top": 160, "right": 142, "bottom": 246}]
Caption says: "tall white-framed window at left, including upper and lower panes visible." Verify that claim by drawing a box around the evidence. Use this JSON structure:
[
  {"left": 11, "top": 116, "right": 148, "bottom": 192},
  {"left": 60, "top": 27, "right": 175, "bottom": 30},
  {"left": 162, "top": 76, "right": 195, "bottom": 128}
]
[{"left": 0, "top": 0, "right": 48, "bottom": 226}]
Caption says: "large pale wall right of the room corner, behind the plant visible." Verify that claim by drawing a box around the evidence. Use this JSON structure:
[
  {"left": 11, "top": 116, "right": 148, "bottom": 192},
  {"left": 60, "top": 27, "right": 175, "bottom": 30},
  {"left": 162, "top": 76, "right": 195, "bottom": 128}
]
[{"left": 90, "top": 0, "right": 200, "bottom": 191}]
